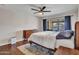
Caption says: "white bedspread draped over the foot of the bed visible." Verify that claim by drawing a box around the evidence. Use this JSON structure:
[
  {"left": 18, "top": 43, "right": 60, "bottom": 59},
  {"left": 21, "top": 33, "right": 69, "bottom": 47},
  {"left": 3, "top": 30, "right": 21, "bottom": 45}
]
[{"left": 28, "top": 31, "right": 59, "bottom": 49}]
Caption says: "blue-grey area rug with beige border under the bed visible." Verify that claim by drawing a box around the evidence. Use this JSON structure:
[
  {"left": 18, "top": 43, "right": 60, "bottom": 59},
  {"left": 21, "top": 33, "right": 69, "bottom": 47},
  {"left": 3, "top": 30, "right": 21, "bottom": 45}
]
[{"left": 17, "top": 44, "right": 54, "bottom": 55}]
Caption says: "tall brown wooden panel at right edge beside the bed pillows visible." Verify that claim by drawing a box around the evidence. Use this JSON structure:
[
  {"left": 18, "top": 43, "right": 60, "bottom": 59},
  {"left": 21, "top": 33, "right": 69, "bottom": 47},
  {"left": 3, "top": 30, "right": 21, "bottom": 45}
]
[{"left": 75, "top": 22, "right": 79, "bottom": 49}]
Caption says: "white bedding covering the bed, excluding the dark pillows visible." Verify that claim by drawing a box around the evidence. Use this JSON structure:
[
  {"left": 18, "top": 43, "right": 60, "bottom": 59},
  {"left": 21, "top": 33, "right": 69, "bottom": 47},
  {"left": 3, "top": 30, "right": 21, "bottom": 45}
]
[{"left": 28, "top": 31, "right": 74, "bottom": 50}]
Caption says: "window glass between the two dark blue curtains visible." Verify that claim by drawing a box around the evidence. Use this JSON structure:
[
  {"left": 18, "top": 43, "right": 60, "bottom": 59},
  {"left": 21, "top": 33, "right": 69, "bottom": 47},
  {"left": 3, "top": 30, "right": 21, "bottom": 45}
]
[{"left": 48, "top": 20, "right": 64, "bottom": 31}]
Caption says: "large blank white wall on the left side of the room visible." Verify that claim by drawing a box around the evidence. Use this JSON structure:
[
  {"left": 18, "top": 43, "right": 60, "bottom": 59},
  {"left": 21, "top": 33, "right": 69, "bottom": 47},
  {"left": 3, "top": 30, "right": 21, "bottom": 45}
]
[{"left": 0, "top": 5, "right": 38, "bottom": 45}]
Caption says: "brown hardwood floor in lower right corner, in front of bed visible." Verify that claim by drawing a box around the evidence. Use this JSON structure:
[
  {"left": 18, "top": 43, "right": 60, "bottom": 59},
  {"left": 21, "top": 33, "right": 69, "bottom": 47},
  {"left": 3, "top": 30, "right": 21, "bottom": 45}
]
[{"left": 55, "top": 46, "right": 79, "bottom": 55}]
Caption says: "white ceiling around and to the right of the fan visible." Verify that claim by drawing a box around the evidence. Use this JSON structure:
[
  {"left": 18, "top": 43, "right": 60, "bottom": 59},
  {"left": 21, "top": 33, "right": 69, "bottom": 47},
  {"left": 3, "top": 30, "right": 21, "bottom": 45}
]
[{"left": 31, "top": 4, "right": 78, "bottom": 16}]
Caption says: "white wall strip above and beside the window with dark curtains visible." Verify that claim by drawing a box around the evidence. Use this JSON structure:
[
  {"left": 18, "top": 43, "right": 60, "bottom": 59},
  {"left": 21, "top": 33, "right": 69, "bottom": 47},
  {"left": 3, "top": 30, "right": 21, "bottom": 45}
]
[{"left": 40, "top": 9, "right": 78, "bottom": 31}]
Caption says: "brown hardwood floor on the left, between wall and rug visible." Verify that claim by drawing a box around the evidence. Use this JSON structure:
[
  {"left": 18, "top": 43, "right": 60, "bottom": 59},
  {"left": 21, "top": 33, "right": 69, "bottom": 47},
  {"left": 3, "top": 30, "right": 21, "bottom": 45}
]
[{"left": 0, "top": 40, "right": 28, "bottom": 55}]
